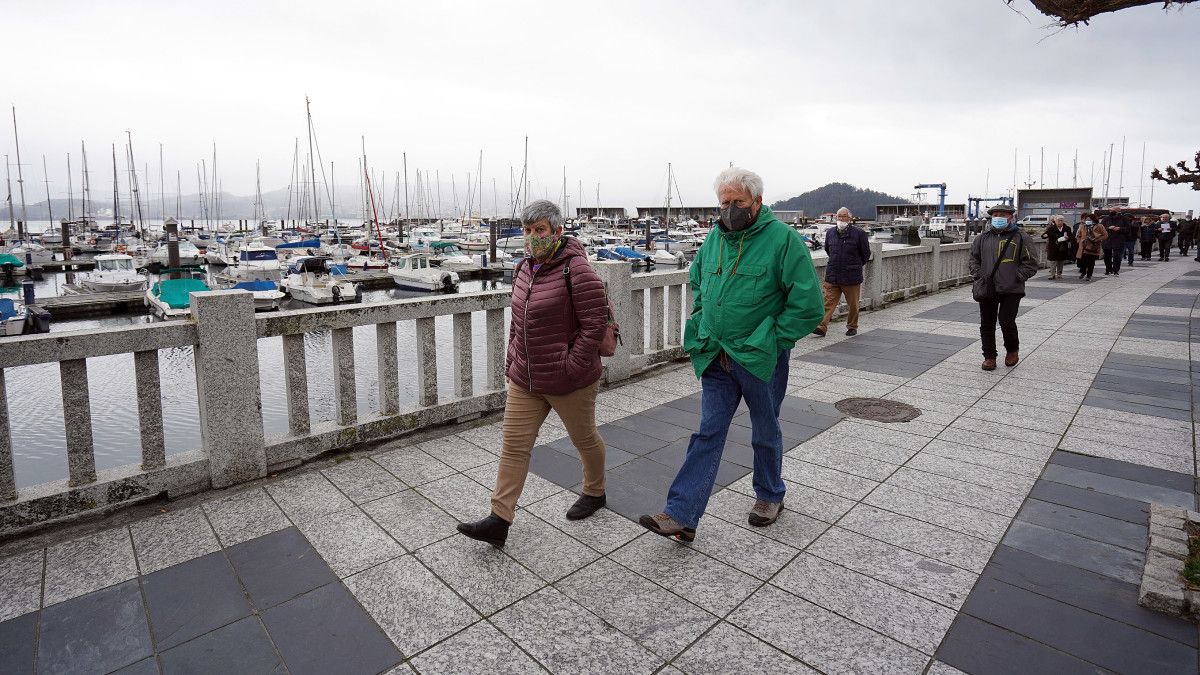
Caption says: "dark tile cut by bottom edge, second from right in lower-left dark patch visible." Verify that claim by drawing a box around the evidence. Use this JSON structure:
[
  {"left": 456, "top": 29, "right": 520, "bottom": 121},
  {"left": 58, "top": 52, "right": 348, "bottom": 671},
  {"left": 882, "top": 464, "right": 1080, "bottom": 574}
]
[{"left": 160, "top": 616, "right": 287, "bottom": 675}]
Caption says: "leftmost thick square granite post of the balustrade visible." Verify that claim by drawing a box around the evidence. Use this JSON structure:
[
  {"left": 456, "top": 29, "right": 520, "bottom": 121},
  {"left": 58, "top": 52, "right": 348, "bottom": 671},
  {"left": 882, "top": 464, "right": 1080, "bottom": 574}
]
[{"left": 192, "top": 291, "right": 266, "bottom": 488}]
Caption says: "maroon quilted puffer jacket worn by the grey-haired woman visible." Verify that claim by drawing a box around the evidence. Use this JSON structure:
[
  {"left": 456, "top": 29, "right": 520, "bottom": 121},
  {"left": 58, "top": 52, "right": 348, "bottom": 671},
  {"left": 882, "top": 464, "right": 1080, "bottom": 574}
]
[{"left": 505, "top": 237, "right": 608, "bottom": 395}]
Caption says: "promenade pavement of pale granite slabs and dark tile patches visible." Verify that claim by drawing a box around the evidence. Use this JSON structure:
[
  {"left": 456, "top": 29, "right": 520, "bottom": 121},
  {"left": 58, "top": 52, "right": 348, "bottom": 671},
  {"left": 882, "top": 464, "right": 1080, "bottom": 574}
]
[{"left": 0, "top": 258, "right": 1200, "bottom": 675}]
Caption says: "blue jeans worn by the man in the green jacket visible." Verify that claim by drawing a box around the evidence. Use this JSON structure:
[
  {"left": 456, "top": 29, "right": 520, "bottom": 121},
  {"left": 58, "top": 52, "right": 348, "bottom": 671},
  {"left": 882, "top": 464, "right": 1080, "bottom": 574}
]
[{"left": 665, "top": 350, "right": 792, "bottom": 528}]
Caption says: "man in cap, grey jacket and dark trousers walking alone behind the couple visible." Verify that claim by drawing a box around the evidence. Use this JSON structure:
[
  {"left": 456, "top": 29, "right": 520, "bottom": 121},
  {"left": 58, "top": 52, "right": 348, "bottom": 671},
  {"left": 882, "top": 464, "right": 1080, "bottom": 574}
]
[{"left": 970, "top": 204, "right": 1038, "bottom": 370}]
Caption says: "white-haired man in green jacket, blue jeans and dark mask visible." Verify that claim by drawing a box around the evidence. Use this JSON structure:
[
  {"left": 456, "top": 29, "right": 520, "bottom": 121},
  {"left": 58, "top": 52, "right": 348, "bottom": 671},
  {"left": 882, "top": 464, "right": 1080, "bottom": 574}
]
[{"left": 638, "top": 167, "right": 824, "bottom": 542}]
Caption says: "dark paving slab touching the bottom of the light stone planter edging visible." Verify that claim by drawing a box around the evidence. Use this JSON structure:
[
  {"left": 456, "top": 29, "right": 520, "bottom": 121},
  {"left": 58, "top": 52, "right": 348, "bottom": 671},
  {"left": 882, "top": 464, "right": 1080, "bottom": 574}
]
[{"left": 983, "top": 545, "right": 1196, "bottom": 647}]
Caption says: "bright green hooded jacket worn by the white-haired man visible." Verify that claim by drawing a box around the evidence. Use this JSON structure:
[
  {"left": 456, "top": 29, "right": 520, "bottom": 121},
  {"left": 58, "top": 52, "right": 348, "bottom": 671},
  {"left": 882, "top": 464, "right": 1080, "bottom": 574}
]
[{"left": 683, "top": 204, "right": 824, "bottom": 382}]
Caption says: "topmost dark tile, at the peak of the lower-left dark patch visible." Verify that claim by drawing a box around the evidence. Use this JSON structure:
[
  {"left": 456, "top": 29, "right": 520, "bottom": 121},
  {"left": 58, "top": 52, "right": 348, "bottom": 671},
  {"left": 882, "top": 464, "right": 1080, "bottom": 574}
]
[{"left": 226, "top": 527, "right": 337, "bottom": 609}]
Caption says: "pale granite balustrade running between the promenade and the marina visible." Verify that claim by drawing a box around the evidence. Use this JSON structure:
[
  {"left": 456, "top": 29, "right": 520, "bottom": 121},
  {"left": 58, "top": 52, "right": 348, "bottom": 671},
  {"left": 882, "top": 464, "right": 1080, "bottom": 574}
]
[{"left": 0, "top": 240, "right": 1044, "bottom": 537}]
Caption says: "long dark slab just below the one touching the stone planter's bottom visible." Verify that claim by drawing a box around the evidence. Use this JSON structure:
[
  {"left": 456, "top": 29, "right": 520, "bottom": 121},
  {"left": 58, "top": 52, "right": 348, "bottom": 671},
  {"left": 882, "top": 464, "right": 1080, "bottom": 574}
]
[{"left": 962, "top": 569, "right": 1198, "bottom": 673}]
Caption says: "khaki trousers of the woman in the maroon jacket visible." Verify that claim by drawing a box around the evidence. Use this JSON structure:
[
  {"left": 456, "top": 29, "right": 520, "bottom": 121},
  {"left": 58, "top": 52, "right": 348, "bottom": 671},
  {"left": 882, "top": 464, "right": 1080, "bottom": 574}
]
[{"left": 492, "top": 381, "right": 605, "bottom": 522}]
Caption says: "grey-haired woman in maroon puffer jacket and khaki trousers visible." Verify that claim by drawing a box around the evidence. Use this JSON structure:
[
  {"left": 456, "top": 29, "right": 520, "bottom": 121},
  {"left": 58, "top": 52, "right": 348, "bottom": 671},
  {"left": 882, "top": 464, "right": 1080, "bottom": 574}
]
[{"left": 458, "top": 199, "right": 608, "bottom": 546}]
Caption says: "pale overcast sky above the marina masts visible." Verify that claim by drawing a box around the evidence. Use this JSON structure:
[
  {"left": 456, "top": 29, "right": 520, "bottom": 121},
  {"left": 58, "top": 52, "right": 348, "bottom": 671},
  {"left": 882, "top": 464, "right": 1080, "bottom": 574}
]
[{"left": 7, "top": 0, "right": 1200, "bottom": 211}]
